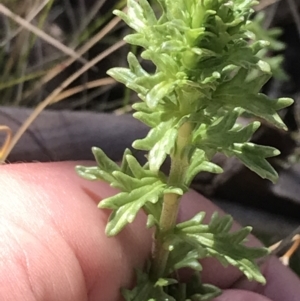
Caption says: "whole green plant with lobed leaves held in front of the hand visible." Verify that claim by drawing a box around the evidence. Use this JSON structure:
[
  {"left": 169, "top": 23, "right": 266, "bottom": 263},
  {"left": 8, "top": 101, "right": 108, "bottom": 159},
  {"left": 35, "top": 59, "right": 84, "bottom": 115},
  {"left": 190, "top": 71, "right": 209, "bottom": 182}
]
[{"left": 77, "top": 0, "right": 292, "bottom": 301}]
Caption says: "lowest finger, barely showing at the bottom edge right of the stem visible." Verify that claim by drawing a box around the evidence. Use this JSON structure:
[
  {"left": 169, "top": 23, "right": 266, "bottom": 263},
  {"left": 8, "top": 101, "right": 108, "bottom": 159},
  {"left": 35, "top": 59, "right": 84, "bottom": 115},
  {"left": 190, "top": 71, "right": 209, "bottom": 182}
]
[{"left": 213, "top": 289, "right": 274, "bottom": 301}]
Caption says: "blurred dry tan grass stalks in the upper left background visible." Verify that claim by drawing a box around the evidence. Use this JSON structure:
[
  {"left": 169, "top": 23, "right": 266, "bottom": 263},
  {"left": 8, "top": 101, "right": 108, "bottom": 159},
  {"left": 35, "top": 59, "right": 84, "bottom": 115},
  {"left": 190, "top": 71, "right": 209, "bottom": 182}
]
[{"left": 0, "top": 0, "right": 125, "bottom": 163}]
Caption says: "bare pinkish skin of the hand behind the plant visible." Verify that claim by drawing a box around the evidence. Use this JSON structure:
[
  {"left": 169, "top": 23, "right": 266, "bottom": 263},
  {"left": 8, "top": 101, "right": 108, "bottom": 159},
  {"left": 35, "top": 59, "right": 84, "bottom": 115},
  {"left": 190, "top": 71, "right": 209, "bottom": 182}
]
[{"left": 0, "top": 162, "right": 300, "bottom": 301}]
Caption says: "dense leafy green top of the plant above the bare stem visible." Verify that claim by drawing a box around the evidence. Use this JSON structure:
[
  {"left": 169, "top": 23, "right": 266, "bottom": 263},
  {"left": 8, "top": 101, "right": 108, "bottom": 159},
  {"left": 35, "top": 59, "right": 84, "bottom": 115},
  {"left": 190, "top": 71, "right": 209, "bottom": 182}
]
[{"left": 108, "top": 0, "right": 292, "bottom": 181}]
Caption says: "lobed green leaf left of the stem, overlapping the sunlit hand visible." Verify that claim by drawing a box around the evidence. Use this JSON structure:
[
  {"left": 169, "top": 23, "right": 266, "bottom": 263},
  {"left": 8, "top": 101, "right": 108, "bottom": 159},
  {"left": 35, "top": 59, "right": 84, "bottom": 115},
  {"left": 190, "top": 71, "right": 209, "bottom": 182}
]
[{"left": 76, "top": 148, "right": 173, "bottom": 236}]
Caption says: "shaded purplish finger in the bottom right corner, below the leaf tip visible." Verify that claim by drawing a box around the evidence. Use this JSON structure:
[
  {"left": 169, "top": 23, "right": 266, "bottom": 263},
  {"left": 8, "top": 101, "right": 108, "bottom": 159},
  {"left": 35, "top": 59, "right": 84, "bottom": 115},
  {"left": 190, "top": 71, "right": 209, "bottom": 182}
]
[{"left": 235, "top": 257, "right": 300, "bottom": 301}]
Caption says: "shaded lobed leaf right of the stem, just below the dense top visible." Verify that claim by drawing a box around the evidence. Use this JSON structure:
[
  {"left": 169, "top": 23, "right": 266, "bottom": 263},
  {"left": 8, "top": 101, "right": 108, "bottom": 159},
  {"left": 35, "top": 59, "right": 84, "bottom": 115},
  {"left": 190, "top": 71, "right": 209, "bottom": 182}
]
[{"left": 191, "top": 110, "right": 279, "bottom": 183}]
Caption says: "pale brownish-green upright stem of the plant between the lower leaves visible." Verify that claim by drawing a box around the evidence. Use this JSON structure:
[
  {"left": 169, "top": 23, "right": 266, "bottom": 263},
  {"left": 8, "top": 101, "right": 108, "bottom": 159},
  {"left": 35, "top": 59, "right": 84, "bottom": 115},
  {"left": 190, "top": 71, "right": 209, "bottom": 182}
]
[{"left": 150, "top": 122, "right": 192, "bottom": 281}]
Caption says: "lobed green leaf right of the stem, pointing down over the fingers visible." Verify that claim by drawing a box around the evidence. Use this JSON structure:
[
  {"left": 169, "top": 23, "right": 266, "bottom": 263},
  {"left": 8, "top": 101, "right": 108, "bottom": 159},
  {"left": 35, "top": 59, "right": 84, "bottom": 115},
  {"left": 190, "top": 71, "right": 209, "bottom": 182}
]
[{"left": 175, "top": 213, "right": 268, "bottom": 283}]
